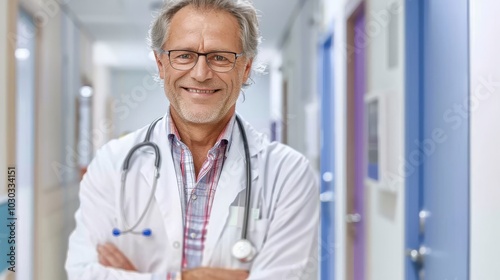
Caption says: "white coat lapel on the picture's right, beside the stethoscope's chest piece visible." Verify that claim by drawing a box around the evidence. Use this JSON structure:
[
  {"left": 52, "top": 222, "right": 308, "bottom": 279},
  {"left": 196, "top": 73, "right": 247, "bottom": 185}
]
[{"left": 202, "top": 117, "right": 260, "bottom": 266}]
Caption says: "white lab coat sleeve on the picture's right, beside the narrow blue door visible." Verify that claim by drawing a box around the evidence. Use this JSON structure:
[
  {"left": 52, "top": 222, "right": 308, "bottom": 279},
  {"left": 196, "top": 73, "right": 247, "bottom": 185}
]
[{"left": 248, "top": 156, "right": 320, "bottom": 280}]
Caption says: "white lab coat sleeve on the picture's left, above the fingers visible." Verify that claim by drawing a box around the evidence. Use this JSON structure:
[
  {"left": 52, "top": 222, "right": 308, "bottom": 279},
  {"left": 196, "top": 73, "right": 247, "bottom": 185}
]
[{"left": 66, "top": 143, "right": 170, "bottom": 280}]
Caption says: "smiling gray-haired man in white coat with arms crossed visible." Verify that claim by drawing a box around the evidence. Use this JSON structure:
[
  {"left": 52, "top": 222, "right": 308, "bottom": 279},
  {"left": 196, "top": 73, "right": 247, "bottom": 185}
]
[{"left": 66, "top": 0, "right": 319, "bottom": 280}]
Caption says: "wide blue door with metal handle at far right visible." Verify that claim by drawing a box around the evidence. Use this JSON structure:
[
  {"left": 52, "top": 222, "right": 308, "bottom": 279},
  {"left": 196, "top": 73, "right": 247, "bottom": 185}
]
[{"left": 405, "top": 0, "right": 469, "bottom": 280}]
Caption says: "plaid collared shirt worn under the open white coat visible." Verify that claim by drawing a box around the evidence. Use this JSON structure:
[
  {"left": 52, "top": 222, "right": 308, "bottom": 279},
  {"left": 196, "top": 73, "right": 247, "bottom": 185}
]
[{"left": 167, "top": 114, "right": 235, "bottom": 279}]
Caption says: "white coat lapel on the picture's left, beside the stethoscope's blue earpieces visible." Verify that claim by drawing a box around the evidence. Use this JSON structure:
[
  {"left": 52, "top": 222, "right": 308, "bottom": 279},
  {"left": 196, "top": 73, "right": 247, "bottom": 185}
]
[{"left": 141, "top": 117, "right": 183, "bottom": 264}]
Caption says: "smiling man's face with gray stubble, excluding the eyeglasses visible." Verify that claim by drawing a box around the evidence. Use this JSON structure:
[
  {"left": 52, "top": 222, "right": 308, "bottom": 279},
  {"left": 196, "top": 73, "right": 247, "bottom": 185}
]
[{"left": 157, "top": 6, "right": 252, "bottom": 124}]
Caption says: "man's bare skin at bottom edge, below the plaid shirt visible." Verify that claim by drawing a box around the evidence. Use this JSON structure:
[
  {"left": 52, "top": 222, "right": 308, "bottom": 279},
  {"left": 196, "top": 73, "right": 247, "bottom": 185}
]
[{"left": 182, "top": 267, "right": 248, "bottom": 280}]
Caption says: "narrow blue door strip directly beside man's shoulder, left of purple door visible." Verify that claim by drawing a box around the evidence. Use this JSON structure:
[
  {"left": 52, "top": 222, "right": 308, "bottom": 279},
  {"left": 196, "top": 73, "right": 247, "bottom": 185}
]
[{"left": 319, "top": 31, "right": 335, "bottom": 280}]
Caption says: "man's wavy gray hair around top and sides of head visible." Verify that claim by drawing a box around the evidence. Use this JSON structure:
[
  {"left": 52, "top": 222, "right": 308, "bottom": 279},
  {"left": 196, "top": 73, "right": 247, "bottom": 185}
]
[{"left": 149, "top": 0, "right": 260, "bottom": 58}]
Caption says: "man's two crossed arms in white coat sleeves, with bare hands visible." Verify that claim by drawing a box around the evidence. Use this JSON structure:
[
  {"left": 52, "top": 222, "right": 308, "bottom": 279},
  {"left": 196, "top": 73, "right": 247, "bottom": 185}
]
[{"left": 66, "top": 143, "right": 319, "bottom": 280}]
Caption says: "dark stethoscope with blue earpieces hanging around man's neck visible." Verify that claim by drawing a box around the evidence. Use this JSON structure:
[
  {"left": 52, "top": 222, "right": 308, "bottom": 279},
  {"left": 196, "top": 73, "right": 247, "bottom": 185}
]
[{"left": 113, "top": 115, "right": 257, "bottom": 262}]
